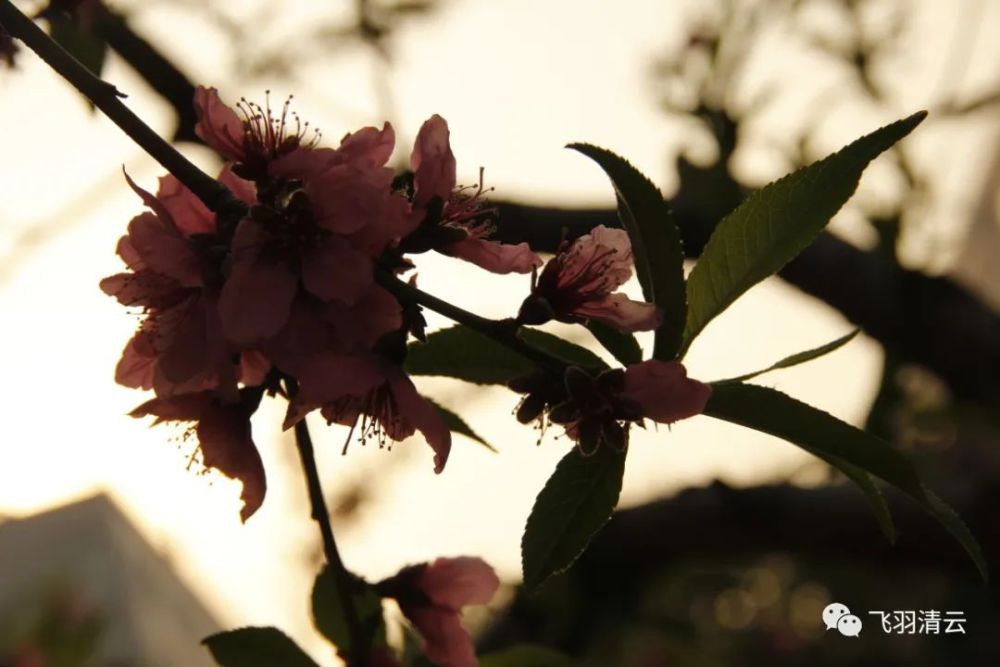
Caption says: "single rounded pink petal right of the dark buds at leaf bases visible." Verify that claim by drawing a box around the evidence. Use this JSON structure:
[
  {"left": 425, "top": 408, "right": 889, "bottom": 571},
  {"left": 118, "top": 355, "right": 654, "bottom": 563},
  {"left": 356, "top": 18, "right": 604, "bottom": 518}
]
[{"left": 622, "top": 359, "right": 712, "bottom": 424}]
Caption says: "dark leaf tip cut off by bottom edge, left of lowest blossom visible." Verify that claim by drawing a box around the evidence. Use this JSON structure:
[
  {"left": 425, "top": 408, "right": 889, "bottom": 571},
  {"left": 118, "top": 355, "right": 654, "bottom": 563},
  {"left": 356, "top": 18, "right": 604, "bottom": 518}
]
[{"left": 207, "top": 628, "right": 319, "bottom": 667}]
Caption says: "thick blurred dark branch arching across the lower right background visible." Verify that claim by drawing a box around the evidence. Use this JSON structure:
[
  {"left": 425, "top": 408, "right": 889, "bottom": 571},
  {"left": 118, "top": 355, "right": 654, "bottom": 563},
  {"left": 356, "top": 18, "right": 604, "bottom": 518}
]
[{"left": 480, "top": 482, "right": 1000, "bottom": 651}]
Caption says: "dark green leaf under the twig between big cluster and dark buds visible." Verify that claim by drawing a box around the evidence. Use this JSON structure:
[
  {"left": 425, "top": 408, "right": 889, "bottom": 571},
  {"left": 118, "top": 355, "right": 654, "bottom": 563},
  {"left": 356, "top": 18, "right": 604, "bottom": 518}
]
[{"left": 403, "top": 325, "right": 535, "bottom": 384}]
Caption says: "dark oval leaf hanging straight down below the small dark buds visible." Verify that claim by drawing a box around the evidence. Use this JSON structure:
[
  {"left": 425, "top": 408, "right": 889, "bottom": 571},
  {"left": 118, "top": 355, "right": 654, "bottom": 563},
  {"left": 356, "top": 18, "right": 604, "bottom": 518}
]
[{"left": 521, "top": 446, "right": 625, "bottom": 589}]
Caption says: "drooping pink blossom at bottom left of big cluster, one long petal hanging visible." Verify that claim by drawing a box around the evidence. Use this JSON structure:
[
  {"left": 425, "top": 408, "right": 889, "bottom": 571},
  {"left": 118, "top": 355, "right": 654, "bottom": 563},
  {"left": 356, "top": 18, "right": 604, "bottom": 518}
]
[{"left": 131, "top": 391, "right": 267, "bottom": 522}]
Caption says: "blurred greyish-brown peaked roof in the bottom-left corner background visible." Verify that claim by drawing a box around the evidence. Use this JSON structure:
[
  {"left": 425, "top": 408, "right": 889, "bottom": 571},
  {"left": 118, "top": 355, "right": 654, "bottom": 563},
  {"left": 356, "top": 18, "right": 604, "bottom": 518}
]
[{"left": 0, "top": 495, "right": 220, "bottom": 667}]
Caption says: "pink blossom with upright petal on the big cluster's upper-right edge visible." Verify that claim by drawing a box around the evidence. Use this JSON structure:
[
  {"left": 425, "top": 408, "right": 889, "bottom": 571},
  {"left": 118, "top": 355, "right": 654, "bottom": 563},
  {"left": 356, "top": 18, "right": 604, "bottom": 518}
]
[{"left": 410, "top": 114, "right": 542, "bottom": 273}]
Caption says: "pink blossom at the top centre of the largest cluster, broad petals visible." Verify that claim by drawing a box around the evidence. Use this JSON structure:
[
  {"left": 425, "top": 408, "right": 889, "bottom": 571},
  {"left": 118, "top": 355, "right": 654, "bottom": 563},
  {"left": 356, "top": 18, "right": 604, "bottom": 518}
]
[{"left": 199, "top": 102, "right": 415, "bottom": 345}]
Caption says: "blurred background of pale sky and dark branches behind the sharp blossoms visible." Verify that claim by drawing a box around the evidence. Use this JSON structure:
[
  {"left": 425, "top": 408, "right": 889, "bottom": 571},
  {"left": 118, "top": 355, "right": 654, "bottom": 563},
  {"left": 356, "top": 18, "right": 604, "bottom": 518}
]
[{"left": 0, "top": 0, "right": 1000, "bottom": 666}]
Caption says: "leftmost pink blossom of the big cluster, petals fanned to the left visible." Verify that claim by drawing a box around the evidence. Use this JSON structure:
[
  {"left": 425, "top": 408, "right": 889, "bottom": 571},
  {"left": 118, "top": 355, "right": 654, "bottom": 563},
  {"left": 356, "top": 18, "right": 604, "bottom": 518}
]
[{"left": 101, "top": 171, "right": 258, "bottom": 396}]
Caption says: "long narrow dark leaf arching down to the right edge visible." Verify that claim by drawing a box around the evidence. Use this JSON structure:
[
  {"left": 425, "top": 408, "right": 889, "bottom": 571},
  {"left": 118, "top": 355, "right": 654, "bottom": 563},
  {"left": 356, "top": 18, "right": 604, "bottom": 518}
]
[{"left": 705, "top": 384, "right": 989, "bottom": 580}]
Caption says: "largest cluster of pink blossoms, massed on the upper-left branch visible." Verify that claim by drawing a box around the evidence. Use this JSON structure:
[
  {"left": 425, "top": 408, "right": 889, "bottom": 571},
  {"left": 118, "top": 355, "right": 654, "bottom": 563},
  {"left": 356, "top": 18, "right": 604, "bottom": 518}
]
[{"left": 101, "top": 88, "right": 541, "bottom": 520}]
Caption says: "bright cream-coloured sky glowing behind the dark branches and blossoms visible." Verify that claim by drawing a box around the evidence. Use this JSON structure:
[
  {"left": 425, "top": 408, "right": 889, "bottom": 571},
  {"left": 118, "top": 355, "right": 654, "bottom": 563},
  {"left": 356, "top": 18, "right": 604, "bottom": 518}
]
[{"left": 0, "top": 0, "right": 1000, "bottom": 664}]
